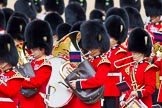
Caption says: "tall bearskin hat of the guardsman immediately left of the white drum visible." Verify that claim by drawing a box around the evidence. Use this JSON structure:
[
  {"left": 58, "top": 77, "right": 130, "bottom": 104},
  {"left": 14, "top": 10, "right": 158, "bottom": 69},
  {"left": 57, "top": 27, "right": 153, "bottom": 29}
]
[{"left": 24, "top": 20, "right": 53, "bottom": 55}]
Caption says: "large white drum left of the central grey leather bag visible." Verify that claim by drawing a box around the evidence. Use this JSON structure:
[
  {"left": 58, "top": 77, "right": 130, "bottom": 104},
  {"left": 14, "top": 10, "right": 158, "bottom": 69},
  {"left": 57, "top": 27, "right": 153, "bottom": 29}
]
[{"left": 46, "top": 57, "right": 73, "bottom": 108}]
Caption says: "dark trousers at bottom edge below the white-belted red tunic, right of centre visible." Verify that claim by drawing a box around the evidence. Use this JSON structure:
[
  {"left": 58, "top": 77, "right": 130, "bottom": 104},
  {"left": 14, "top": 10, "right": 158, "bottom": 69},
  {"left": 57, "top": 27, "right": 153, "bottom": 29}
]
[{"left": 103, "top": 96, "right": 120, "bottom": 108}]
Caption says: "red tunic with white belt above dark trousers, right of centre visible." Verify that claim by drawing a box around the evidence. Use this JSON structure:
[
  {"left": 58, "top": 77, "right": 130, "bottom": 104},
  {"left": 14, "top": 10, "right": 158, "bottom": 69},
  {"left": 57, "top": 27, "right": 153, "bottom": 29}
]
[{"left": 104, "top": 45, "right": 127, "bottom": 96}]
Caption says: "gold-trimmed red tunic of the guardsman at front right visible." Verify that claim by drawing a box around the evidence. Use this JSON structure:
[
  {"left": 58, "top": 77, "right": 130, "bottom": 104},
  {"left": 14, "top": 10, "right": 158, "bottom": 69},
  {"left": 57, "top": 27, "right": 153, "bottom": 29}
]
[{"left": 124, "top": 60, "right": 157, "bottom": 108}]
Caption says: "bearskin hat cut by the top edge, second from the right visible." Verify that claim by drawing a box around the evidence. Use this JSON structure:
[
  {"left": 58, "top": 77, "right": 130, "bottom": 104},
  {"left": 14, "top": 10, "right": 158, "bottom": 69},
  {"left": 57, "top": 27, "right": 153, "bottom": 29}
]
[{"left": 120, "top": 0, "right": 141, "bottom": 12}]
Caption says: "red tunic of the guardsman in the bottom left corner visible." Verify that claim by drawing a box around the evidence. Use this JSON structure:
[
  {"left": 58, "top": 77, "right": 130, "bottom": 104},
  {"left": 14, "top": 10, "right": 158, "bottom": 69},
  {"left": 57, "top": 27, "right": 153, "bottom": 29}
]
[{"left": 0, "top": 70, "right": 23, "bottom": 108}]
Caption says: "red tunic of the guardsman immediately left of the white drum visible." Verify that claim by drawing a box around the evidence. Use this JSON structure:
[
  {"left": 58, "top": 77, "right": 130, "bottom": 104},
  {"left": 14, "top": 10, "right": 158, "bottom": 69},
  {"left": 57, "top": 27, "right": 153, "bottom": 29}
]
[{"left": 20, "top": 60, "right": 52, "bottom": 108}]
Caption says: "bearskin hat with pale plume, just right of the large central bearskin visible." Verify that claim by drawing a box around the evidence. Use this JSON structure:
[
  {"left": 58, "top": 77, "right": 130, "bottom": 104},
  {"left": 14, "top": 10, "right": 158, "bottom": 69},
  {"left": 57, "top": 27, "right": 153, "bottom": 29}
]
[{"left": 105, "top": 15, "right": 128, "bottom": 44}]
